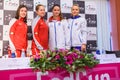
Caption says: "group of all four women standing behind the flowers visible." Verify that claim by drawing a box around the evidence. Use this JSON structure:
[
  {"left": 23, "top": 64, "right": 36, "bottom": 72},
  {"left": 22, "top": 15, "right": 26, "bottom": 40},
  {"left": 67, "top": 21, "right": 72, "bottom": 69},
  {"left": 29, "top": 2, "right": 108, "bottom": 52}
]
[{"left": 9, "top": 4, "right": 87, "bottom": 57}]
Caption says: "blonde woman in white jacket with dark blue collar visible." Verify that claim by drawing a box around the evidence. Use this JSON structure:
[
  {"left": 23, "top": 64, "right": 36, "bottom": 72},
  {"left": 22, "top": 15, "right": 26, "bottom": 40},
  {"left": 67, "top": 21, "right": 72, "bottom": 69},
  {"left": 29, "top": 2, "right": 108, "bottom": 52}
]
[{"left": 68, "top": 4, "right": 87, "bottom": 51}]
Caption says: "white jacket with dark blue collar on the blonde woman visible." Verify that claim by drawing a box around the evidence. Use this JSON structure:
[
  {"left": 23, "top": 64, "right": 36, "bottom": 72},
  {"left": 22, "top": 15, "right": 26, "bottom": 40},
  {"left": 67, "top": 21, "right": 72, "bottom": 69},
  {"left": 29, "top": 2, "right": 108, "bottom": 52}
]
[{"left": 66, "top": 16, "right": 87, "bottom": 47}]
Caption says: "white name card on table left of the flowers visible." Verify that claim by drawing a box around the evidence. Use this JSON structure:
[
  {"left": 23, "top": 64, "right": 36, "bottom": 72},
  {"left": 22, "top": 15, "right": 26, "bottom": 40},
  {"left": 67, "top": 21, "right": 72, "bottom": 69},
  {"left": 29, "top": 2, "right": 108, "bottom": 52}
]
[{"left": 0, "top": 58, "right": 30, "bottom": 70}]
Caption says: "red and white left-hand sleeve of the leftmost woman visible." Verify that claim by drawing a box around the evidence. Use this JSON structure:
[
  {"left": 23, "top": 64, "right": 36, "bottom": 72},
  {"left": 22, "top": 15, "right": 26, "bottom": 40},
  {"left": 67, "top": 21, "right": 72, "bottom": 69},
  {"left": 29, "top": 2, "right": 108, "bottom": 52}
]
[{"left": 9, "top": 19, "right": 16, "bottom": 51}]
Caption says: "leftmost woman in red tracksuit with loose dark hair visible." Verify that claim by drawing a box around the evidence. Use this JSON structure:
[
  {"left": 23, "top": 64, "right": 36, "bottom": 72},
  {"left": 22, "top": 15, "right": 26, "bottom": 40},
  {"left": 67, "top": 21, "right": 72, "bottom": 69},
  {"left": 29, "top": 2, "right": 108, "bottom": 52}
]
[{"left": 9, "top": 5, "right": 27, "bottom": 57}]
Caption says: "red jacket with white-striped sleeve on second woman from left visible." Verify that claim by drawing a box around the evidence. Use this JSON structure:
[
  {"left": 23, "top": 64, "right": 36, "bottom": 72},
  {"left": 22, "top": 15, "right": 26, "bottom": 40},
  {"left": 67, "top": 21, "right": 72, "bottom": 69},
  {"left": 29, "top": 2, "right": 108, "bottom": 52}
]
[{"left": 32, "top": 16, "right": 48, "bottom": 53}]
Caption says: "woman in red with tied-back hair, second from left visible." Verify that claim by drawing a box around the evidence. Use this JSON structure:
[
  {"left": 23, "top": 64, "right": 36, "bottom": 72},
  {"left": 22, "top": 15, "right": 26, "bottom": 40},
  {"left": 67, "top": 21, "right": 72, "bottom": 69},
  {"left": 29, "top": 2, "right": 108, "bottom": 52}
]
[{"left": 32, "top": 4, "right": 48, "bottom": 55}]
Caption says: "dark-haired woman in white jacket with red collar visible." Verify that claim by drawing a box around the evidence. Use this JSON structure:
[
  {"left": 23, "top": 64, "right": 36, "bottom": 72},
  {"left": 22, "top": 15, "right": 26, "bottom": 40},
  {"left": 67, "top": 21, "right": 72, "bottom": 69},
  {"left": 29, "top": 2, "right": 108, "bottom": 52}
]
[{"left": 48, "top": 4, "right": 69, "bottom": 50}]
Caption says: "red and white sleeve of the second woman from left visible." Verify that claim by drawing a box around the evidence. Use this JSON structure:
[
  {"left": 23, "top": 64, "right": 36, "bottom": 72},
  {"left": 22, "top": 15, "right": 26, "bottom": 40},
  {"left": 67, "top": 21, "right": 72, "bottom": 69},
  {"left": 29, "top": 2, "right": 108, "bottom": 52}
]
[{"left": 32, "top": 19, "right": 43, "bottom": 50}]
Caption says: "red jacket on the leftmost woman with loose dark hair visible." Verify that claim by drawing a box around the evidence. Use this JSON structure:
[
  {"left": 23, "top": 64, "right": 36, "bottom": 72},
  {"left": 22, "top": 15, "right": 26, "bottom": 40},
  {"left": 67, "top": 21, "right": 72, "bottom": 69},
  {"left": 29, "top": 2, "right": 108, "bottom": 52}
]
[{"left": 9, "top": 18, "right": 27, "bottom": 50}]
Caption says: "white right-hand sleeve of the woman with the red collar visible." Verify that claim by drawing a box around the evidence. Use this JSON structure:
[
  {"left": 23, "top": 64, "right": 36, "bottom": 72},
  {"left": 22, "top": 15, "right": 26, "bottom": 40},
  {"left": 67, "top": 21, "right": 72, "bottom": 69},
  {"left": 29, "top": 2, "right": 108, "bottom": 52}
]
[{"left": 62, "top": 19, "right": 70, "bottom": 49}]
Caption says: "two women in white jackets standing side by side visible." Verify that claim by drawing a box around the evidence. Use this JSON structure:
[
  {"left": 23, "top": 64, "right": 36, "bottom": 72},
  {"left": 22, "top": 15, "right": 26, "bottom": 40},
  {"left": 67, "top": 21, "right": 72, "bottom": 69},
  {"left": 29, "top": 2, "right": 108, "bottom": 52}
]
[{"left": 48, "top": 4, "right": 87, "bottom": 51}]
